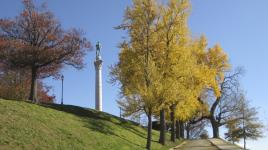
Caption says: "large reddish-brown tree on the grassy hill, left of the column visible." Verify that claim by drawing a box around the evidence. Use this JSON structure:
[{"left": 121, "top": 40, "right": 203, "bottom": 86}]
[{"left": 0, "top": 0, "right": 90, "bottom": 102}]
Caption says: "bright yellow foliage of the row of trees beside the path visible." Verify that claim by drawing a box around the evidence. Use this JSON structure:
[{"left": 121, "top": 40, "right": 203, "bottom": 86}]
[{"left": 113, "top": 0, "right": 229, "bottom": 120}]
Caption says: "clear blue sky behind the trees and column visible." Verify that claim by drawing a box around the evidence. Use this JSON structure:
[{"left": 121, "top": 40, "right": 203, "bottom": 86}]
[{"left": 0, "top": 0, "right": 268, "bottom": 150}]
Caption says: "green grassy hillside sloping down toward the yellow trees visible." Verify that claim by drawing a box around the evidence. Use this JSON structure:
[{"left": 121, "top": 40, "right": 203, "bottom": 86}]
[{"left": 0, "top": 99, "right": 180, "bottom": 150}]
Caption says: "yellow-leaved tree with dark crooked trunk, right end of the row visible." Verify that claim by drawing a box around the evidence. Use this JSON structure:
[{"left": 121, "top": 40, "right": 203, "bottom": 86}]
[{"left": 181, "top": 36, "right": 233, "bottom": 138}]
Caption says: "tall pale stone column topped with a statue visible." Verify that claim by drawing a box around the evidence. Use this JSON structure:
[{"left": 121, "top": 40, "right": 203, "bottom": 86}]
[{"left": 94, "top": 42, "right": 102, "bottom": 111}]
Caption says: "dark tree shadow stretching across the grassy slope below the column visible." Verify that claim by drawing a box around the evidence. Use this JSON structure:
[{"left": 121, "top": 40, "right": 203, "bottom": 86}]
[{"left": 40, "top": 103, "right": 146, "bottom": 148}]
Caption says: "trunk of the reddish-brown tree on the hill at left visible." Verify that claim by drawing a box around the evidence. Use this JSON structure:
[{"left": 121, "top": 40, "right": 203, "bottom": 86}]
[{"left": 29, "top": 67, "right": 37, "bottom": 102}]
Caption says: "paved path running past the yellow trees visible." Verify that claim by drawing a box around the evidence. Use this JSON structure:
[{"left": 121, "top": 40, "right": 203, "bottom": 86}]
[{"left": 173, "top": 139, "right": 242, "bottom": 150}]
